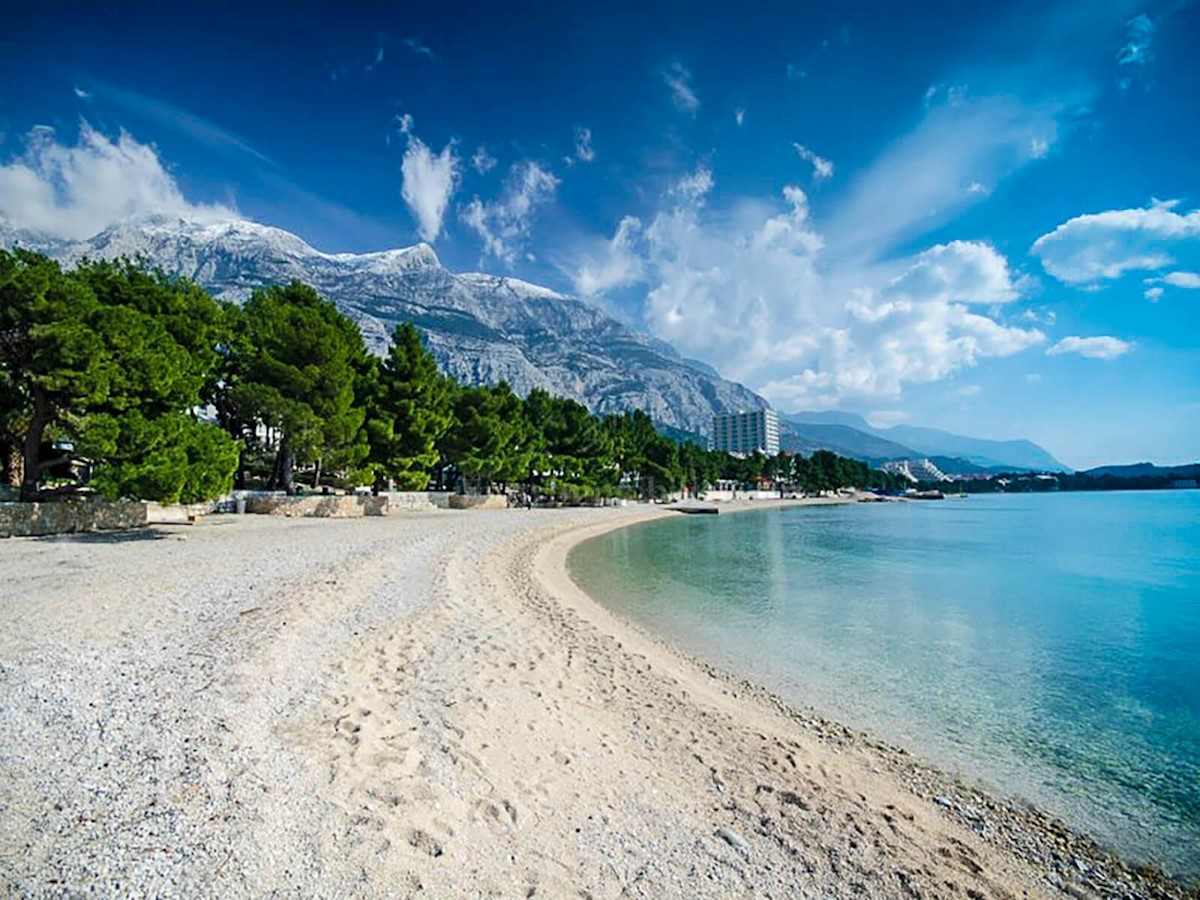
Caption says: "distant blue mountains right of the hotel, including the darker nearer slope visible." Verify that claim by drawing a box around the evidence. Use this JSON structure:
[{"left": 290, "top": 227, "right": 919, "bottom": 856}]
[{"left": 780, "top": 412, "right": 1070, "bottom": 475}]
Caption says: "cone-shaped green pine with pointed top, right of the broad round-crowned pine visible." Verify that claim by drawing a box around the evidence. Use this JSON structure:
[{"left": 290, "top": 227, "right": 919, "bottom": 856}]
[{"left": 367, "top": 323, "right": 455, "bottom": 491}]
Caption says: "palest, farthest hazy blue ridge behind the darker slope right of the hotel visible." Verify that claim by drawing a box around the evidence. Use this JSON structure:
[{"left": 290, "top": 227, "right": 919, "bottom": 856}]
[{"left": 781, "top": 410, "right": 1070, "bottom": 474}]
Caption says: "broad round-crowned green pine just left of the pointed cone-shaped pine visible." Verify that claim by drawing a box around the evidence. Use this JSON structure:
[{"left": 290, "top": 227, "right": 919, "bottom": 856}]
[{"left": 218, "top": 281, "right": 368, "bottom": 493}]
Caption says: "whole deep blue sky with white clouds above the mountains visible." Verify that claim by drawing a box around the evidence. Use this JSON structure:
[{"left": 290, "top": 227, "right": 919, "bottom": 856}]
[{"left": 0, "top": 0, "right": 1200, "bottom": 468}]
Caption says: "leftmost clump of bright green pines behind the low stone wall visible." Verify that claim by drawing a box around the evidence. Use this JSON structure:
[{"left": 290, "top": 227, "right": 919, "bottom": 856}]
[{"left": 0, "top": 251, "right": 233, "bottom": 500}]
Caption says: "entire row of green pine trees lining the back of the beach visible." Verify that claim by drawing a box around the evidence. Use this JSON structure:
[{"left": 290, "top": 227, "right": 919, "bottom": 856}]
[{"left": 0, "top": 251, "right": 902, "bottom": 502}]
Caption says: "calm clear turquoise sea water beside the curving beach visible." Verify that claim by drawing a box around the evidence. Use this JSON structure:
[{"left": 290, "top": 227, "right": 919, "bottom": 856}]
[{"left": 570, "top": 491, "right": 1200, "bottom": 878}]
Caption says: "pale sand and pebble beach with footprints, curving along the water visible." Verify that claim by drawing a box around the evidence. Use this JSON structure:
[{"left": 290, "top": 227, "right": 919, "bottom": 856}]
[{"left": 0, "top": 504, "right": 1187, "bottom": 898}]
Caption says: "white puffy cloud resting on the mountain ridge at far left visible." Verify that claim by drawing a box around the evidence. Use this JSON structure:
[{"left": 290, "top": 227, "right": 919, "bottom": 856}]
[{"left": 0, "top": 121, "right": 238, "bottom": 240}]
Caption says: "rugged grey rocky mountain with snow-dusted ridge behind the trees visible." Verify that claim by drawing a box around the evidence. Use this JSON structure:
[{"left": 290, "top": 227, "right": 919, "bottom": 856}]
[{"left": 0, "top": 216, "right": 767, "bottom": 433}]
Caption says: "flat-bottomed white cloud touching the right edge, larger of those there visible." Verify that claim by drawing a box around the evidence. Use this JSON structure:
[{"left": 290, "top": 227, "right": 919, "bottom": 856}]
[{"left": 1030, "top": 200, "right": 1200, "bottom": 284}]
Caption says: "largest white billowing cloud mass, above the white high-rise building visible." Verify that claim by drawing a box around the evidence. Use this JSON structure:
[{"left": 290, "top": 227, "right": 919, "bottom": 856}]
[{"left": 575, "top": 167, "right": 1045, "bottom": 409}]
